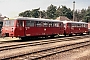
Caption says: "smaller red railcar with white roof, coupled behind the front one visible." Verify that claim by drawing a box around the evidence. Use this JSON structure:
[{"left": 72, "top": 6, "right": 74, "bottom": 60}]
[{"left": 63, "top": 21, "right": 88, "bottom": 35}]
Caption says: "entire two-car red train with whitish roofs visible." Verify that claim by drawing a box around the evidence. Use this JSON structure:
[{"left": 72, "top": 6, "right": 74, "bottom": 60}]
[{"left": 1, "top": 17, "right": 88, "bottom": 38}]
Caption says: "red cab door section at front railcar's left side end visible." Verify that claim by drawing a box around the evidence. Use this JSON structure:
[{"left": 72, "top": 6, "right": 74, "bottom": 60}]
[{"left": 17, "top": 20, "right": 25, "bottom": 37}]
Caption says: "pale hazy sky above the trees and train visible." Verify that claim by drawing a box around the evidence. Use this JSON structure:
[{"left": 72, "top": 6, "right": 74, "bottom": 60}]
[{"left": 0, "top": 0, "right": 90, "bottom": 17}]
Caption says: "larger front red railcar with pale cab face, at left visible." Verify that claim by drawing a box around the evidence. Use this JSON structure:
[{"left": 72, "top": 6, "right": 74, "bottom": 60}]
[{"left": 1, "top": 17, "right": 64, "bottom": 38}]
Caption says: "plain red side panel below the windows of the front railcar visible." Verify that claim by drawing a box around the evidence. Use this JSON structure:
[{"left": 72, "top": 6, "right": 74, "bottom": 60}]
[{"left": 25, "top": 23, "right": 64, "bottom": 36}]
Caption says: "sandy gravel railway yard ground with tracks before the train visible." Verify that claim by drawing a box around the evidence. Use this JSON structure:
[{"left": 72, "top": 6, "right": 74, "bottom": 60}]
[{"left": 0, "top": 35, "right": 90, "bottom": 60}]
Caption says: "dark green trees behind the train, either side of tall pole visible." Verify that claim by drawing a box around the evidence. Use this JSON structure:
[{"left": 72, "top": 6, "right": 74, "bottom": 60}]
[{"left": 19, "top": 4, "right": 90, "bottom": 22}]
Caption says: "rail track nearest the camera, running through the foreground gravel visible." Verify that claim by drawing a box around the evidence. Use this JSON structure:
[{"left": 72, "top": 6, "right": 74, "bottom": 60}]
[{"left": 11, "top": 41, "right": 90, "bottom": 60}]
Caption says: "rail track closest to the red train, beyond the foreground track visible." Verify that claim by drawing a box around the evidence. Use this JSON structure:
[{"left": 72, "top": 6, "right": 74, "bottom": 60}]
[{"left": 0, "top": 35, "right": 89, "bottom": 51}]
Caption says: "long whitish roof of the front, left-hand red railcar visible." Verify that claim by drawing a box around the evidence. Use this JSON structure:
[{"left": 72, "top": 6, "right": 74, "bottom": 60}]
[{"left": 3, "top": 17, "right": 61, "bottom": 22}]
